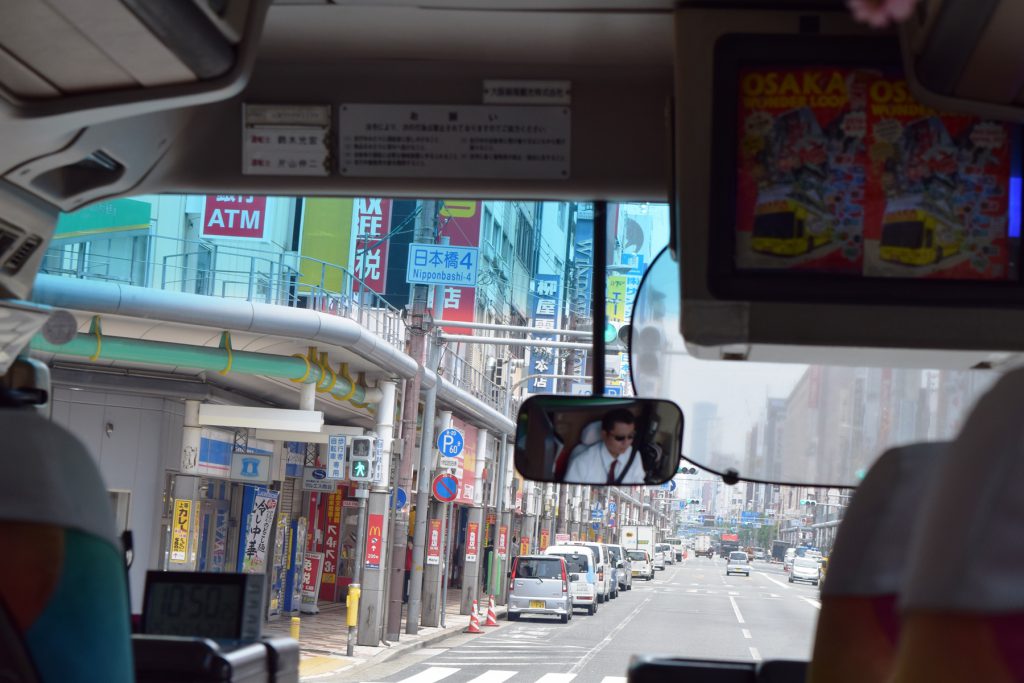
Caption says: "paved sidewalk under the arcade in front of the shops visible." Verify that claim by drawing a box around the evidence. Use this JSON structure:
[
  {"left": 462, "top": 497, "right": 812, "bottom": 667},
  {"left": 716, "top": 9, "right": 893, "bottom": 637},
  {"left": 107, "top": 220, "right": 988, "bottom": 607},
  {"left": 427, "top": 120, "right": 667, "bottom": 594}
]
[{"left": 263, "top": 589, "right": 505, "bottom": 680}]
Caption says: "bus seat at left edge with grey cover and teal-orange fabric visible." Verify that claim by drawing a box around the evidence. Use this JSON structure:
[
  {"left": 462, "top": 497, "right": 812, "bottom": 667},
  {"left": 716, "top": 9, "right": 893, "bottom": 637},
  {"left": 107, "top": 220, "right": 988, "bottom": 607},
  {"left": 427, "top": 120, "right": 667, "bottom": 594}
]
[{"left": 0, "top": 408, "right": 133, "bottom": 683}]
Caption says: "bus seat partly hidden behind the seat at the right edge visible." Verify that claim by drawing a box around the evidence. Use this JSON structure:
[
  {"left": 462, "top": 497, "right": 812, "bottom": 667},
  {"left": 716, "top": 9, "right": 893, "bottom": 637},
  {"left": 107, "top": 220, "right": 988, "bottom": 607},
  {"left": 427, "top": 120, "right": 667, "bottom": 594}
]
[{"left": 807, "top": 442, "right": 948, "bottom": 683}]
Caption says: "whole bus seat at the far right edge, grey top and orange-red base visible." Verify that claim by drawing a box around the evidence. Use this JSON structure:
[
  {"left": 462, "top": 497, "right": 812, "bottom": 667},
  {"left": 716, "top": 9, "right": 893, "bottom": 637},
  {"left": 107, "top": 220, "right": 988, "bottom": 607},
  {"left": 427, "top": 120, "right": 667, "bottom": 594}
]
[{"left": 893, "top": 370, "right": 1024, "bottom": 683}]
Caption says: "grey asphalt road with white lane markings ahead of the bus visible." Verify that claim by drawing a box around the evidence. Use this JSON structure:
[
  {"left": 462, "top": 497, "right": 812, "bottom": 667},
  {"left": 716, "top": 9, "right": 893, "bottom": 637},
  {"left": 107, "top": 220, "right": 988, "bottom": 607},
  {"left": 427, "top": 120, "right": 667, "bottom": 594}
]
[{"left": 331, "top": 557, "right": 820, "bottom": 683}]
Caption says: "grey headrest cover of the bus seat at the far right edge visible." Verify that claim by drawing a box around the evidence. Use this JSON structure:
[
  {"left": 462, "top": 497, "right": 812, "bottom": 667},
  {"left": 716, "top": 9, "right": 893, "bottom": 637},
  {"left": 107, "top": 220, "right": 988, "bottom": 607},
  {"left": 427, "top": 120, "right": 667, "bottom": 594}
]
[{"left": 900, "top": 370, "right": 1024, "bottom": 614}]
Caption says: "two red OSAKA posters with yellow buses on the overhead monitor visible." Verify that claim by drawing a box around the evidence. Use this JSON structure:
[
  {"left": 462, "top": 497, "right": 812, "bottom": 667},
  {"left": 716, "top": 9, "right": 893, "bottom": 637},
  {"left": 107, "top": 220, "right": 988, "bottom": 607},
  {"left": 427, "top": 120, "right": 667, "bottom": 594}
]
[{"left": 735, "top": 67, "right": 1020, "bottom": 281}]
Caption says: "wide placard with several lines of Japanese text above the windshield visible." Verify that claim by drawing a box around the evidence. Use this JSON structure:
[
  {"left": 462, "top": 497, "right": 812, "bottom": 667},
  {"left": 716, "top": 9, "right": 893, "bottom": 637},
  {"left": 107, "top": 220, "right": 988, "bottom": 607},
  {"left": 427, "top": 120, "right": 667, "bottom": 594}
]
[{"left": 338, "top": 104, "right": 571, "bottom": 180}]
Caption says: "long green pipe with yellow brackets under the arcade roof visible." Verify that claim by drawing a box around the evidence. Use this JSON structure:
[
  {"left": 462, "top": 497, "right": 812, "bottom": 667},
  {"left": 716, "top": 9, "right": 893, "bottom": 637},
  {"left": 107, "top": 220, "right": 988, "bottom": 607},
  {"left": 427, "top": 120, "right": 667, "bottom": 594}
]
[{"left": 32, "top": 333, "right": 367, "bottom": 403}]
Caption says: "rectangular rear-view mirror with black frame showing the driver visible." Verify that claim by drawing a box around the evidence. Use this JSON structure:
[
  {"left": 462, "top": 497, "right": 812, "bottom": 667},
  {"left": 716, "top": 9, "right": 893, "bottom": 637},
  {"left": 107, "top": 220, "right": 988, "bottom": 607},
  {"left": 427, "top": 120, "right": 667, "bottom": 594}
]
[{"left": 515, "top": 396, "right": 683, "bottom": 485}]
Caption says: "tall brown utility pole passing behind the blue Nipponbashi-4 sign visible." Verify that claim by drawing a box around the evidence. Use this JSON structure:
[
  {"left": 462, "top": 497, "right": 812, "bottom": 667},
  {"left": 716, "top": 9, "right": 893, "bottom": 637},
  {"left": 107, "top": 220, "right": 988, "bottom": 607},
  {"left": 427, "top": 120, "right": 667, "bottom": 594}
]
[{"left": 385, "top": 201, "right": 437, "bottom": 641}]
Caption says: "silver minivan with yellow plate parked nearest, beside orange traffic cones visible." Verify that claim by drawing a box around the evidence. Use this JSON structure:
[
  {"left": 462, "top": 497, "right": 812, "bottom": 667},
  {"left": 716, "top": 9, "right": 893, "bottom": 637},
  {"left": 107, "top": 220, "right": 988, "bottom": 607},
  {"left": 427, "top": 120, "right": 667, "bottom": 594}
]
[{"left": 508, "top": 555, "right": 577, "bottom": 624}]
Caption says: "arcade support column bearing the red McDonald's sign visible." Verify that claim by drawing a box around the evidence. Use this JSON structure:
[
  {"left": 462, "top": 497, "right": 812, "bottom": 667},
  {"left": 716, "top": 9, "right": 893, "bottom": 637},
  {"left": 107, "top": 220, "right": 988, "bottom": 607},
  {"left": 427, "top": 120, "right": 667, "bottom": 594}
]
[{"left": 356, "top": 381, "right": 395, "bottom": 647}]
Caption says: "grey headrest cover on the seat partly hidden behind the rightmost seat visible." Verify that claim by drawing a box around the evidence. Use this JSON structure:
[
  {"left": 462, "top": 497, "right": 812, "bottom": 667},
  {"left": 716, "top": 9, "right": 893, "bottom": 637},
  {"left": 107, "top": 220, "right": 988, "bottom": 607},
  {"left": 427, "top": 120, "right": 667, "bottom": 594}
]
[{"left": 821, "top": 441, "right": 949, "bottom": 597}]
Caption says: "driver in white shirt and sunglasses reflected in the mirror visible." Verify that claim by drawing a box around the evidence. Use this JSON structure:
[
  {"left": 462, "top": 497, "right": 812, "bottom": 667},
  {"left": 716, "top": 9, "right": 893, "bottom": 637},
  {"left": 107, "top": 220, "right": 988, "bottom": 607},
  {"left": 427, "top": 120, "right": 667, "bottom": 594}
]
[{"left": 564, "top": 409, "right": 644, "bottom": 485}]
